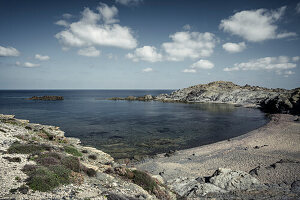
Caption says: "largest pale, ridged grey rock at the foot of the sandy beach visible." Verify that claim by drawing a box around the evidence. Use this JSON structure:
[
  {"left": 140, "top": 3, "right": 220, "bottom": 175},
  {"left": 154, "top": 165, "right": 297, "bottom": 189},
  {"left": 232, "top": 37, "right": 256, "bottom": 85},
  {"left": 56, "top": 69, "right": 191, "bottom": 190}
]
[{"left": 209, "top": 168, "right": 261, "bottom": 191}]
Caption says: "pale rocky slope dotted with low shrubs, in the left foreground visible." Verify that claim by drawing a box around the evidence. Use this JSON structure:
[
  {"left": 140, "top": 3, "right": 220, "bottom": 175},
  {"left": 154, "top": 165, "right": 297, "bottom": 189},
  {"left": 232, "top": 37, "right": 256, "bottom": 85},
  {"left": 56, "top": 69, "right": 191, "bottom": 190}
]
[{"left": 0, "top": 114, "right": 177, "bottom": 200}]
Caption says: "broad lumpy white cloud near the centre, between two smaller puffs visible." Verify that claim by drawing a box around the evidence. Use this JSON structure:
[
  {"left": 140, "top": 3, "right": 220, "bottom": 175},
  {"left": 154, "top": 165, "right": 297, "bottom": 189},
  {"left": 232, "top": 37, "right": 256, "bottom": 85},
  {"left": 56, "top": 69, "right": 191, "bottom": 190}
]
[{"left": 162, "top": 31, "right": 216, "bottom": 61}]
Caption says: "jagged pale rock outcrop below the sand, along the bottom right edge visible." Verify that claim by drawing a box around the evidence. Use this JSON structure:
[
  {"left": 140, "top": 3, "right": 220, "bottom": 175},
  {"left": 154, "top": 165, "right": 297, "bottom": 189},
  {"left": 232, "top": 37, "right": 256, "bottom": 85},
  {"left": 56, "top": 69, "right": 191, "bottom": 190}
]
[{"left": 167, "top": 168, "right": 300, "bottom": 200}]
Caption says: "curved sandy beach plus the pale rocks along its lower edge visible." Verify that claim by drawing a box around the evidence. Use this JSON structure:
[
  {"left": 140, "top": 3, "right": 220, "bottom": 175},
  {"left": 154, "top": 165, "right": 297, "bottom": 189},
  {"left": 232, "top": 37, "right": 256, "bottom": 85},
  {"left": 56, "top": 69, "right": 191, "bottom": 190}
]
[{"left": 136, "top": 114, "right": 300, "bottom": 199}]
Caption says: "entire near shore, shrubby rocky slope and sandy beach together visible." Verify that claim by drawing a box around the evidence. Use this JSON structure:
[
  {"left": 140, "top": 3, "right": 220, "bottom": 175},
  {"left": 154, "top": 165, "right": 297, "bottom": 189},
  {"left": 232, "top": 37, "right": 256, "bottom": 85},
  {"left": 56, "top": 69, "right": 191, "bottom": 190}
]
[{"left": 0, "top": 114, "right": 300, "bottom": 200}]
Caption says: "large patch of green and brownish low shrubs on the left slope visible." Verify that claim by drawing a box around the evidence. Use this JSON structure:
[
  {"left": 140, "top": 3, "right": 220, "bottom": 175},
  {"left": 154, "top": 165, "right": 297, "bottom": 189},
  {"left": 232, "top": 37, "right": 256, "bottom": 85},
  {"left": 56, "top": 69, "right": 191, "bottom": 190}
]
[{"left": 8, "top": 142, "right": 96, "bottom": 192}]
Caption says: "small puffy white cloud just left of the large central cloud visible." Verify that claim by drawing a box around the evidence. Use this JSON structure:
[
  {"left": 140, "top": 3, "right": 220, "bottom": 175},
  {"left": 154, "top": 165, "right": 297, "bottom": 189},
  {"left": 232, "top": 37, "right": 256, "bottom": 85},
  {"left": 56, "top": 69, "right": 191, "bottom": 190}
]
[{"left": 126, "top": 46, "right": 162, "bottom": 62}]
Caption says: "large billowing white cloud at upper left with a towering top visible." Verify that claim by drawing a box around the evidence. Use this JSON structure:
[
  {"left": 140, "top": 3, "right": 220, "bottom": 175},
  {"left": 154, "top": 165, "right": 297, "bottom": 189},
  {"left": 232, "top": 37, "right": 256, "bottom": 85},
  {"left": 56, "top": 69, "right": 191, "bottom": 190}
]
[{"left": 55, "top": 4, "right": 137, "bottom": 49}]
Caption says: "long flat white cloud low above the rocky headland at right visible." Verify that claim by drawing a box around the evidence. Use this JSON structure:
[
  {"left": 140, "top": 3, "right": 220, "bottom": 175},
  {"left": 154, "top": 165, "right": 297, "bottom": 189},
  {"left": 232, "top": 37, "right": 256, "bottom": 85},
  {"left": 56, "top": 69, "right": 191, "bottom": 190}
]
[{"left": 223, "top": 56, "right": 297, "bottom": 73}]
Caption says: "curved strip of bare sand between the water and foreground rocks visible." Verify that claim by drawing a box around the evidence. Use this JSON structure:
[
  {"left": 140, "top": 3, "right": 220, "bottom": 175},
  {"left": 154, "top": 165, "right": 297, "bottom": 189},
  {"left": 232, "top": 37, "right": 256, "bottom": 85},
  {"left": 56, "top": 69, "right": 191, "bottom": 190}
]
[{"left": 136, "top": 114, "right": 300, "bottom": 185}]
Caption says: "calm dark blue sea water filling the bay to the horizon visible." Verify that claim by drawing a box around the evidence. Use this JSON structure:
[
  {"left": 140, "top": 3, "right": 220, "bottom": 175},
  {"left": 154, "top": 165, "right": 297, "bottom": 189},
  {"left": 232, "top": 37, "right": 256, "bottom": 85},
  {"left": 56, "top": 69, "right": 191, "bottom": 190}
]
[{"left": 0, "top": 90, "right": 268, "bottom": 158}]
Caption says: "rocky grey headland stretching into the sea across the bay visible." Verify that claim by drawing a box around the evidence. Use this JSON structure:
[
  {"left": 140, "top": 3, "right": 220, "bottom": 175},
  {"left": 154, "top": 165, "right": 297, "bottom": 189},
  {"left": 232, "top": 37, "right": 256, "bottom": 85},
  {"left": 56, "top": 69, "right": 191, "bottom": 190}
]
[{"left": 110, "top": 81, "right": 300, "bottom": 114}]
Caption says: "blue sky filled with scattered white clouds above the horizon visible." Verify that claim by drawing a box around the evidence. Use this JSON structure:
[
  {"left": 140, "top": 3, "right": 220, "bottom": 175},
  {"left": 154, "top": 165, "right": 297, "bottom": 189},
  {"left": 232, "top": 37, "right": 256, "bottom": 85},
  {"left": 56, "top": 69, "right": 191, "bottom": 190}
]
[{"left": 0, "top": 0, "right": 300, "bottom": 89}]
